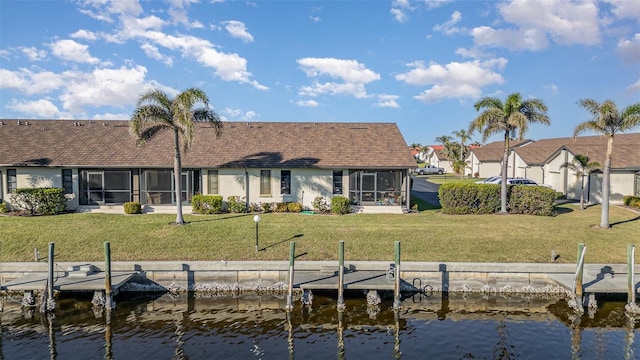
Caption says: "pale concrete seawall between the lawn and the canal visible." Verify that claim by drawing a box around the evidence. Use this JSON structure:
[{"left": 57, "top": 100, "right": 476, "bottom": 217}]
[{"left": 5, "top": 261, "right": 627, "bottom": 294}]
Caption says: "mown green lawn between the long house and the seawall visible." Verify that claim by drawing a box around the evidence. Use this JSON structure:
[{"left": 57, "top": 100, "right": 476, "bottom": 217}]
[{"left": 0, "top": 205, "right": 640, "bottom": 263}]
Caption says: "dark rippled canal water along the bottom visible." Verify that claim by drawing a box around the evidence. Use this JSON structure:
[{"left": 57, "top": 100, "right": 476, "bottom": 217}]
[{"left": 0, "top": 293, "right": 640, "bottom": 360}]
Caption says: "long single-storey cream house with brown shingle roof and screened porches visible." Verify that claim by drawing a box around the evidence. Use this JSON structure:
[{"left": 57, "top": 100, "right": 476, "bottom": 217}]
[{"left": 0, "top": 120, "right": 415, "bottom": 212}]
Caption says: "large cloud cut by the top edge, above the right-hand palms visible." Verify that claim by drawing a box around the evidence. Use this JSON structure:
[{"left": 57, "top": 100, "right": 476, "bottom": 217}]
[{"left": 471, "top": 0, "right": 601, "bottom": 51}]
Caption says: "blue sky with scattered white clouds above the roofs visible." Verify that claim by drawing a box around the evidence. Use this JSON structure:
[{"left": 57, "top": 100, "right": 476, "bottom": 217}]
[{"left": 0, "top": 0, "right": 640, "bottom": 144}]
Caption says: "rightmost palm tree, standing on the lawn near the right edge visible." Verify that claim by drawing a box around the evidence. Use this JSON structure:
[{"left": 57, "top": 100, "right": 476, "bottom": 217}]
[{"left": 573, "top": 99, "right": 640, "bottom": 229}]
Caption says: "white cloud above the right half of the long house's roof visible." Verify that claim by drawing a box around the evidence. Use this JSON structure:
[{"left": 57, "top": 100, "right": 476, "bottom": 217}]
[{"left": 297, "top": 58, "right": 380, "bottom": 98}]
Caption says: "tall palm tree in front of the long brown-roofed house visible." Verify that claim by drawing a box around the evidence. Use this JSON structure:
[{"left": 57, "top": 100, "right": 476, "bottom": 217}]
[{"left": 129, "top": 88, "right": 222, "bottom": 225}]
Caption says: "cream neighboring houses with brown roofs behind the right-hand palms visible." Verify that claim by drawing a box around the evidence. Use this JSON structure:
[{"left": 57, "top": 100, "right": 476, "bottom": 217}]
[{"left": 469, "top": 133, "right": 640, "bottom": 203}]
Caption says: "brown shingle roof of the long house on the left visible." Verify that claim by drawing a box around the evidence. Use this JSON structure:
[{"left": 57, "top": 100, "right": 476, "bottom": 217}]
[{"left": 0, "top": 120, "right": 415, "bottom": 168}]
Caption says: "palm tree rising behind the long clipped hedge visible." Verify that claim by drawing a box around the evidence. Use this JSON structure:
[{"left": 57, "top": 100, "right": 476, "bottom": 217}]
[{"left": 469, "top": 92, "right": 551, "bottom": 213}]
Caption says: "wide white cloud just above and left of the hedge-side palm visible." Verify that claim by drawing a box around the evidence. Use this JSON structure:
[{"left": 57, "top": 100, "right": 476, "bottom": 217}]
[{"left": 396, "top": 58, "right": 507, "bottom": 103}]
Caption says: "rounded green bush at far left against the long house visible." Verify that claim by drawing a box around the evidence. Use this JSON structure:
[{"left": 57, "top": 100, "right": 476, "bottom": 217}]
[{"left": 9, "top": 188, "right": 67, "bottom": 215}]
